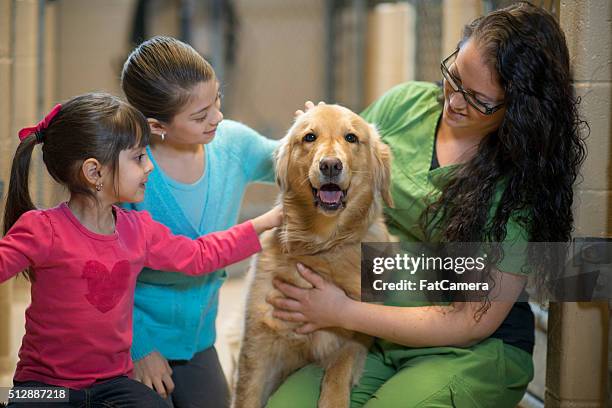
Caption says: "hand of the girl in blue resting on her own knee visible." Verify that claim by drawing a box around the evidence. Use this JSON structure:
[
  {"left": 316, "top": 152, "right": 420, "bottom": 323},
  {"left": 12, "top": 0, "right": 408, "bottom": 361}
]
[{"left": 134, "top": 351, "right": 174, "bottom": 399}]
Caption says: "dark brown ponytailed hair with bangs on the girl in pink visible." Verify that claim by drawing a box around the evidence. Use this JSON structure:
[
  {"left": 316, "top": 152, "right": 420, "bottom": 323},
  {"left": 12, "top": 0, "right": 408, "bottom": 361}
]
[{"left": 4, "top": 93, "right": 149, "bottom": 278}]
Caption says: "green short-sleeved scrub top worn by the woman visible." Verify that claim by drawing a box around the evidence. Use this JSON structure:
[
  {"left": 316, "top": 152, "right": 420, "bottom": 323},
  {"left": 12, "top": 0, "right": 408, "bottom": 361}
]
[{"left": 362, "top": 82, "right": 530, "bottom": 274}]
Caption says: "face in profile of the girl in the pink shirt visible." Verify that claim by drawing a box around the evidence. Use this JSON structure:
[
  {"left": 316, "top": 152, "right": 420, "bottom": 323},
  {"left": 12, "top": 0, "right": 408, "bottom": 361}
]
[{"left": 104, "top": 147, "right": 153, "bottom": 203}]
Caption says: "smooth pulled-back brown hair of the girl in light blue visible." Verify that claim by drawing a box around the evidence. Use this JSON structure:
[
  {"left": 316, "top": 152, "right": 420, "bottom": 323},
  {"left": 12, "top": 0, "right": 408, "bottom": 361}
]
[{"left": 121, "top": 36, "right": 215, "bottom": 123}]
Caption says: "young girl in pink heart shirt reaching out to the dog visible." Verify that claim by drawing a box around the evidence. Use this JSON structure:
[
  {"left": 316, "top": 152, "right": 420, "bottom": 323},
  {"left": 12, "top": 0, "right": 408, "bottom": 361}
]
[{"left": 0, "top": 94, "right": 281, "bottom": 407}]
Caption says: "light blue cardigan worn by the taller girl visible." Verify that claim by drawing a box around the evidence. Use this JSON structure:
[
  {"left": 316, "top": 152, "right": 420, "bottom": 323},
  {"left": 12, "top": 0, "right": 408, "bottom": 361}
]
[{"left": 124, "top": 120, "right": 278, "bottom": 360}]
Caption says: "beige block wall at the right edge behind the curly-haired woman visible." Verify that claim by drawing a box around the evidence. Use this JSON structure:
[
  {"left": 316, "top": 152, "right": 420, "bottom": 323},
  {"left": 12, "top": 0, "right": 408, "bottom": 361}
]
[{"left": 546, "top": 0, "right": 612, "bottom": 407}]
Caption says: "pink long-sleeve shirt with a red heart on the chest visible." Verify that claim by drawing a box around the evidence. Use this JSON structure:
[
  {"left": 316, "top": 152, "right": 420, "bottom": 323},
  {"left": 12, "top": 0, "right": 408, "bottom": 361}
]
[{"left": 0, "top": 204, "right": 261, "bottom": 389}]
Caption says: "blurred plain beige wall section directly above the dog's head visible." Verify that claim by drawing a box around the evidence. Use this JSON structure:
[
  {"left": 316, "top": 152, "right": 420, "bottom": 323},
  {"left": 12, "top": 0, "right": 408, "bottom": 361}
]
[{"left": 226, "top": 0, "right": 325, "bottom": 138}]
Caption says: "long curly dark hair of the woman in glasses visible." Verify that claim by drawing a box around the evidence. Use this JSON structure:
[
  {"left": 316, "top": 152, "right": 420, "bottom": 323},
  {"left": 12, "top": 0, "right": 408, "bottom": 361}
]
[{"left": 423, "top": 2, "right": 588, "bottom": 302}]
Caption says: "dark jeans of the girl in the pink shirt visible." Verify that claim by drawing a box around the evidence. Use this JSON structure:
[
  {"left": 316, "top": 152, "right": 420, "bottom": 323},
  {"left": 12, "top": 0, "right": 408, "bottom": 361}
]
[{"left": 7, "top": 376, "right": 168, "bottom": 408}]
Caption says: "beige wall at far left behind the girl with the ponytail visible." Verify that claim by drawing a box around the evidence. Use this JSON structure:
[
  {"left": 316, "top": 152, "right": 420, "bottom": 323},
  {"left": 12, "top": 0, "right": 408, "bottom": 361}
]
[{"left": 0, "top": 0, "right": 73, "bottom": 385}]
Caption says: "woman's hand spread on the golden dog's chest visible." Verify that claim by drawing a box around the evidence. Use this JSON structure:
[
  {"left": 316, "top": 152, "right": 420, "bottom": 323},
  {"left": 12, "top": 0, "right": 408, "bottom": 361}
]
[{"left": 267, "top": 264, "right": 352, "bottom": 334}]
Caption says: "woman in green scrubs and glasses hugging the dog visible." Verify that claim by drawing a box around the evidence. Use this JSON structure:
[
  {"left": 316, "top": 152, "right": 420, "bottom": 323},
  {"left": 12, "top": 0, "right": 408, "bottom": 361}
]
[{"left": 268, "top": 3, "right": 585, "bottom": 408}]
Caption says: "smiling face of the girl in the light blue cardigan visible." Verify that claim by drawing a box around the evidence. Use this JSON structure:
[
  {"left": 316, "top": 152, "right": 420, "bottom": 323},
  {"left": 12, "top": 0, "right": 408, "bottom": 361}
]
[{"left": 166, "top": 81, "right": 223, "bottom": 145}]
